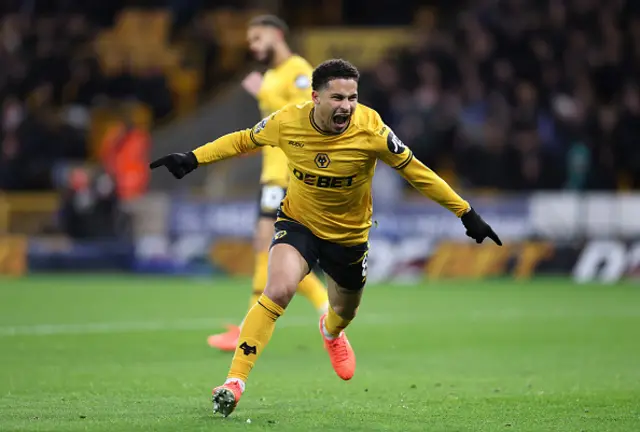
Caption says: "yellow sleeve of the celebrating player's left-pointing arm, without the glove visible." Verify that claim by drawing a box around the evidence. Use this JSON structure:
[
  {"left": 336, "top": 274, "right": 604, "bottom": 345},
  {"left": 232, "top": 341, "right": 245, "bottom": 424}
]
[{"left": 193, "top": 113, "right": 280, "bottom": 165}]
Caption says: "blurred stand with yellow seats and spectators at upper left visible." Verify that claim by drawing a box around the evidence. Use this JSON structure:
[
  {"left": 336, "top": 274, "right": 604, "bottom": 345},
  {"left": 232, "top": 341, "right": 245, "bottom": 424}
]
[{"left": 0, "top": 2, "right": 272, "bottom": 190}]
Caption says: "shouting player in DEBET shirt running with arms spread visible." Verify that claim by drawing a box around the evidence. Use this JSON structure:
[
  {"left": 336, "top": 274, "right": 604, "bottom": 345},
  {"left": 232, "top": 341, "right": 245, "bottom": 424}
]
[{"left": 151, "top": 59, "right": 502, "bottom": 416}]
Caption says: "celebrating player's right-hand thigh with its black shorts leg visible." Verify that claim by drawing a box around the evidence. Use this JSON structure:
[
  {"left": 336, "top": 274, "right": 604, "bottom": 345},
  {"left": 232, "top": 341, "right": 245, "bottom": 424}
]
[{"left": 320, "top": 242, "right": 369, "bottom": 318}]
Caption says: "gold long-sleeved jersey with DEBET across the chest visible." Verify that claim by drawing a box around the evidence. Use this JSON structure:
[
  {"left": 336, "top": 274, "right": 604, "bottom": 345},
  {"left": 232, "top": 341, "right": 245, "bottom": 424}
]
[{"left": 194, "top": 101, "right": 469, "bottom": 246}]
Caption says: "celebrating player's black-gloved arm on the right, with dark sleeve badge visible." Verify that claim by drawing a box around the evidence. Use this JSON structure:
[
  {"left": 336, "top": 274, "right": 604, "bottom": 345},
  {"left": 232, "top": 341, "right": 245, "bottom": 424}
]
[{"left": 378, "top": 125, "right": 502, "bottom": 246}]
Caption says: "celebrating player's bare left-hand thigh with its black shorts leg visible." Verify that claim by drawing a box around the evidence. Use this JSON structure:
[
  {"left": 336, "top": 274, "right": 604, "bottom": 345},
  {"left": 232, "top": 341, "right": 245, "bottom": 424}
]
[{"left": 265, "top": 221, "right": 318, "bottom": 307}]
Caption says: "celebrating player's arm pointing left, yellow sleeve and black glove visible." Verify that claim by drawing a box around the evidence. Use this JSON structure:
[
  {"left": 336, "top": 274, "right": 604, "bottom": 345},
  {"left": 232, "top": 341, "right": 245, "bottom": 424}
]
[{"left": 149, "top": 113, "right": 279, "bottom": 179}]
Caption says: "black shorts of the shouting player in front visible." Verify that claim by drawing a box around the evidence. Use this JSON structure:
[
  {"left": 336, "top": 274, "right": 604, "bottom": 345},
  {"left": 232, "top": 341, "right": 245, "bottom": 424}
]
[{"left": 271, "top": 213, "right": 369, "bottom": 291}]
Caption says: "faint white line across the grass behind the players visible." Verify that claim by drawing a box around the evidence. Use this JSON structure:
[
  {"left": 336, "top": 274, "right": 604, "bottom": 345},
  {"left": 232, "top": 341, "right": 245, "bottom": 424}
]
[{"left": 0, "top": 315, "right": 402, "bottom": 337}]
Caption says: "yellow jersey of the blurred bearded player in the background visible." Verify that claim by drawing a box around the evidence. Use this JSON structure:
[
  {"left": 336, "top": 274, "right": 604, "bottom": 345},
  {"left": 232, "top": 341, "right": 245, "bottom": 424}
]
[{"left": 257, "top": 55, "right": 313, "bottom": 187}]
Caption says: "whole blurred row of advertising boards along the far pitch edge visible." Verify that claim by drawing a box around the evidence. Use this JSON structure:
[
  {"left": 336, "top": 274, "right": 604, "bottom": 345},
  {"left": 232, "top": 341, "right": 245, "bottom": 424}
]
[{"left": 18, "top": 195, "right": 640, "bottom": 283}]
